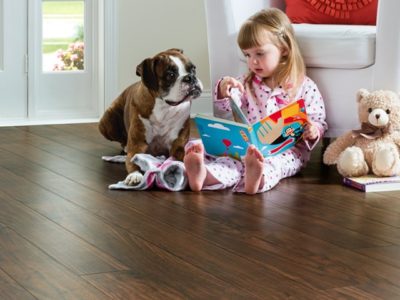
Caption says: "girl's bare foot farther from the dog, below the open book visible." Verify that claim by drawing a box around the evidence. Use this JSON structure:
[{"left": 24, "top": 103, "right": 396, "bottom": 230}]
[{"left": 244, "top": 145, "right": 264, "bottom": 195}]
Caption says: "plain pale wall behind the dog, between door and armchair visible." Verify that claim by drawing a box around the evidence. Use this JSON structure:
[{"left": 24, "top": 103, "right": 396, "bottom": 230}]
[{"left": 115, "top": 0, "right": 211, "bottom": 111}]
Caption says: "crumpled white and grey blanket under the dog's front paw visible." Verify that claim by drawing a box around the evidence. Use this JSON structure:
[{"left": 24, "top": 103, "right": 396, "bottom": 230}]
[{"left": 102, "top": 154, "right": 187, "bottom": 191}]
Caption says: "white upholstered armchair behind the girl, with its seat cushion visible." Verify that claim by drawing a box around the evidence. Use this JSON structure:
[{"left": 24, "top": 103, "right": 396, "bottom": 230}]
[{"left": 205, "top": 0, "right": 400, "bottom": 137}]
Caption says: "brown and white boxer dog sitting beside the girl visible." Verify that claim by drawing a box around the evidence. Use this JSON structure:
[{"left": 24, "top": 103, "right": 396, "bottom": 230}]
[{"left": 99, "top": 49, "right": 203, "bottom": 185}]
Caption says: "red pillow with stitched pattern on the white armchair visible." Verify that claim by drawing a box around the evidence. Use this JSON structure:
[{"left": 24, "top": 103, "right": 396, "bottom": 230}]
[{"left": 286, "top": 0, "right": 376, "bottom": 25}]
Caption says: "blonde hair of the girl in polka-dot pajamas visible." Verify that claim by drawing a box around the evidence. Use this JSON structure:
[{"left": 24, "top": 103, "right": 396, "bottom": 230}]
[{"left": 237, "top": 8, "right": 305, "bottom": 98}]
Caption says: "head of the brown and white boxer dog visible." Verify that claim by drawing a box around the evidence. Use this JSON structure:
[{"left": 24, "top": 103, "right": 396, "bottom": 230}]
[{"left": 136, "top": 49, "right": 203, "bottom": 106}]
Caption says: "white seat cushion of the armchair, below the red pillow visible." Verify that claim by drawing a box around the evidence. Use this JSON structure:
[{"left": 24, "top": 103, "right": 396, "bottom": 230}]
[{"left": 293, "top": 24, "right": 376, "bottom": 69}]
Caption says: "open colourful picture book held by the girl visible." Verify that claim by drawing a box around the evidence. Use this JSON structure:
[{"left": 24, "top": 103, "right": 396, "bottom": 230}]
[{"left": 195, "top": 99, "right": 307, "bottom": 160}]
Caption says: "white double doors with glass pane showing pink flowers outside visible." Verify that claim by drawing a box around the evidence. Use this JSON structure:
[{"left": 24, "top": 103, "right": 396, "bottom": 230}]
[{"left": 0, "top": 0, "right": 104, "bottom": 125}]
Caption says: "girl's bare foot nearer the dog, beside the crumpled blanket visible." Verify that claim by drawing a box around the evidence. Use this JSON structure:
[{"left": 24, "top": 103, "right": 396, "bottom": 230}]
[{"left": 183, "top": 144, "right": 207, "bottom": 192}]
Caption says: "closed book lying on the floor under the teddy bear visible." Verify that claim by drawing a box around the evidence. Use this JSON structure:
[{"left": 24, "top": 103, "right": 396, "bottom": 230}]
[{"left": 343, "top": 175, "right": 400, "bottom": 193}]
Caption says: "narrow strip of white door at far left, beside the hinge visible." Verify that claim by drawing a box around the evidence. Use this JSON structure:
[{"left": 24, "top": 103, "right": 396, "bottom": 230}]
[{"left": 0, "top": 0, "right": 28, "bottom": 120}]
